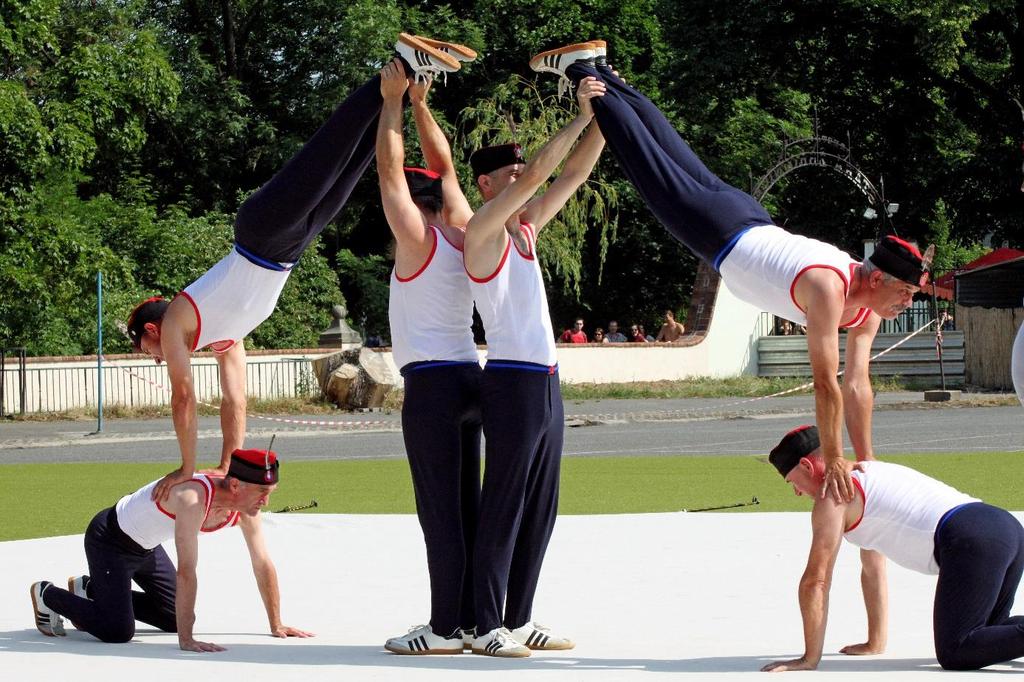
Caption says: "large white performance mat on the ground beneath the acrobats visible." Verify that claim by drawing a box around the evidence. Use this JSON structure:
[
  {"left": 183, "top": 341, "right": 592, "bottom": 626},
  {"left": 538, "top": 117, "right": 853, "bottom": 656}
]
[{"left": 0, "top": 513, "right": 1024, "bottom": 682}]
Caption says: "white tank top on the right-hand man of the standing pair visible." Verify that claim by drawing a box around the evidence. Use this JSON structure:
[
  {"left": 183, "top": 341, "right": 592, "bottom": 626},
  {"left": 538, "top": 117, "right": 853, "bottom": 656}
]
[{"left": 469, "top": 223, "right": 558, "bottom": 367}]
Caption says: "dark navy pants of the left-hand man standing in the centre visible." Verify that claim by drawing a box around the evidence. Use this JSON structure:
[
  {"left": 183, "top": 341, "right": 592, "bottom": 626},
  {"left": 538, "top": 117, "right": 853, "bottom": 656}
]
[{"left": 401, "top": 363, "right": 482, "bottom": 637}]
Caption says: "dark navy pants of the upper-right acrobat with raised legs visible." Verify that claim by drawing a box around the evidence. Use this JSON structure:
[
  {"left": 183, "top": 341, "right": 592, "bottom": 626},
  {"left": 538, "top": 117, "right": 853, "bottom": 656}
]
[{"left": 565, "top": 62, "right": 772, "bottom": 269}]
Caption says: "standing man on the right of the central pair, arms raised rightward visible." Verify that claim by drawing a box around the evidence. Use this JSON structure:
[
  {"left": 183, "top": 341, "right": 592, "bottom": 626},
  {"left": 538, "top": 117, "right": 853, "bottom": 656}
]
[{"left": 465, "top": 50, "right": 604, "bottom": 656}]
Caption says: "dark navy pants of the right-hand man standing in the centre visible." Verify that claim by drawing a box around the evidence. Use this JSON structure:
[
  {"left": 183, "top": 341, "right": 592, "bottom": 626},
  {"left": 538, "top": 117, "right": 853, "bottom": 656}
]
[{"left": 473, "top": 360, "right": 565, "bottom": 634}]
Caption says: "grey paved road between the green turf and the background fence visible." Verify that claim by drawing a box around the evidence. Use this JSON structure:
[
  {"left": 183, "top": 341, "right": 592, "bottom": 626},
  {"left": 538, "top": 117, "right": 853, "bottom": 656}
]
[{"left": 0, "top": 393, "right": 1024, "bottom": 464}]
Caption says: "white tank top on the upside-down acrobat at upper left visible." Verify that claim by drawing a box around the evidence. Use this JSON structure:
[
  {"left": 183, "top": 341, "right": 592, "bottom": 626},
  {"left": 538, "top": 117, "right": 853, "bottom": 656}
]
[{"left": 179, "top": 249, "right": 292, "bottom": 353}]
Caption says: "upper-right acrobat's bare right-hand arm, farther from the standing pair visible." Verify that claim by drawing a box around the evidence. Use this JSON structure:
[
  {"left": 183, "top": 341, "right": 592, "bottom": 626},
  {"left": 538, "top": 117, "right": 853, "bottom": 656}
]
[{"left": 843, "top": 312, "right": 882, "bottom": 462}]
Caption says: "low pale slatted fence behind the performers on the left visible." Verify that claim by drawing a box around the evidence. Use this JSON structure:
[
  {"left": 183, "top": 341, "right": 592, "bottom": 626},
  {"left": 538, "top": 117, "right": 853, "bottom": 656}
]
[{"left": 0, "top": 358, "right": 318, "bottom": 414}]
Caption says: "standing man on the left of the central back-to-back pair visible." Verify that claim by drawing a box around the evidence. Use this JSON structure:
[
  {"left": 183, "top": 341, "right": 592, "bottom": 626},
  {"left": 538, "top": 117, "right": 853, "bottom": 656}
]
[{"left": 377, "top": 44, "right": 481, "bottom": 654}]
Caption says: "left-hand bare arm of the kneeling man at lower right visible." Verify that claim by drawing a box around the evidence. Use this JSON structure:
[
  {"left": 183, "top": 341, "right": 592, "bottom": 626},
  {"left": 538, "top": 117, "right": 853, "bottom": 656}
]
[{"left": 761, "top": 498, "right": 846, "bottom": 673}]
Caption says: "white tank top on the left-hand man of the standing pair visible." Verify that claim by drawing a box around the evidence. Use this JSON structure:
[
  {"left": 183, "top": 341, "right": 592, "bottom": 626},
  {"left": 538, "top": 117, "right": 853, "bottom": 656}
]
[{"left": 388, "top": 225, "right": 479, "bottom": 369}]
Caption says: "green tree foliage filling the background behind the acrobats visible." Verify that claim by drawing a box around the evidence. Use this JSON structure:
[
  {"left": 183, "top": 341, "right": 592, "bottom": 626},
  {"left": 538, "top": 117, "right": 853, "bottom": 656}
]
[{"left": 0, "top": 0, "right": 1024, "bottom": 353}]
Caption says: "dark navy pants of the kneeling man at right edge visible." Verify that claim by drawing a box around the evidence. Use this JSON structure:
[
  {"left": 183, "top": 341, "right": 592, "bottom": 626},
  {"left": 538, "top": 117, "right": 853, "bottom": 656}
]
[{"left": 934, "top": 502, "right": 1024, "bottom": 670}]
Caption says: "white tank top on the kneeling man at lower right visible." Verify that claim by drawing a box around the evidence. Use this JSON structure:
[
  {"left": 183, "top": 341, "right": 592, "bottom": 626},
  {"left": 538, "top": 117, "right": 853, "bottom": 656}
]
[{"left": 846, "top": 461, "right": 980, "bottom": 574}]
